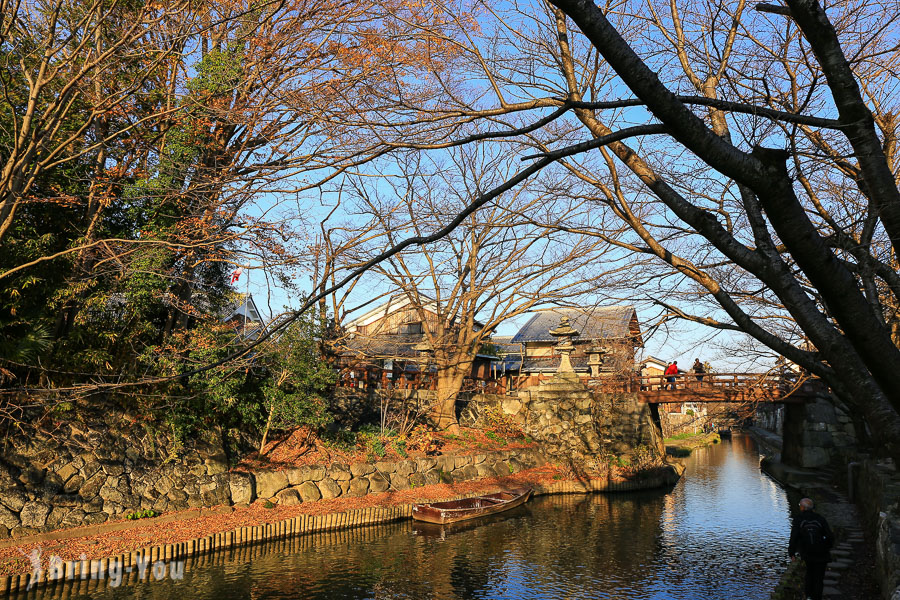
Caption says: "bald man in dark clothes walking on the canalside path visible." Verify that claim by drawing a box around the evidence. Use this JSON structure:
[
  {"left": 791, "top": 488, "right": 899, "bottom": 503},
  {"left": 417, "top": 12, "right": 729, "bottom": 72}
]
[{"left": 788, "top": 498, "right": 834, "bottom": 600}]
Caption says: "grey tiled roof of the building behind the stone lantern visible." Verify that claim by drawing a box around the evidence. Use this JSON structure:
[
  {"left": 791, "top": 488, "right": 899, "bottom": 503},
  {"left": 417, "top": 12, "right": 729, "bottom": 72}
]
[{"left": 511, "top": 306, "right": 640, "bottom": 344}]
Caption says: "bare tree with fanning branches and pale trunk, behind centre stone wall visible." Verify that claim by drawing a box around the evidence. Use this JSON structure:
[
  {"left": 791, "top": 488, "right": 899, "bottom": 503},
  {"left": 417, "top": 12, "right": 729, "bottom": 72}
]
[{"left": 338, "top": 147, "right": 615, "bottom": 430}]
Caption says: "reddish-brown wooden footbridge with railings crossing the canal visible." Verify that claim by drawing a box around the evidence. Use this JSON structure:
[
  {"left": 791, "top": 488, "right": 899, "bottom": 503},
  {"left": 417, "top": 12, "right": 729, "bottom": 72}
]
[{"left": 588, "top": 373, "right": 826, "bottom": 404}]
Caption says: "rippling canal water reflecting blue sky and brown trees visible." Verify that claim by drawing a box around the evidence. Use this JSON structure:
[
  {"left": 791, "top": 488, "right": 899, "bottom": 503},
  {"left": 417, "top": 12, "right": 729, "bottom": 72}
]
[{"left": 29, "top": 435, "right": 790, "bottom": 600}]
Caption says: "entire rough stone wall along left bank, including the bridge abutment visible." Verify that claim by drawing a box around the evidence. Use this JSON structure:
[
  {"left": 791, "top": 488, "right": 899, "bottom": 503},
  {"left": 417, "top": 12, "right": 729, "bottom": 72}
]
[{"left": 0, "top": 390, "right": 676, "bottom": 540}]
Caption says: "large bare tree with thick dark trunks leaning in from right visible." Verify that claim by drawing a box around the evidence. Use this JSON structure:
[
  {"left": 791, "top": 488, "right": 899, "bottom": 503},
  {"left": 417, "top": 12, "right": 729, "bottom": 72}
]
[{"left": 312, "top": 0, "right": 900, "bottom": 451}]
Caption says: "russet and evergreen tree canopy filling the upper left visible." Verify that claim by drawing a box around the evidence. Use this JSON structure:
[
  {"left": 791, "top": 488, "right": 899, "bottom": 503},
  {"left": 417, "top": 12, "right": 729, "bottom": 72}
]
[{"left": 0, "top": 0, "right": 450, "bottom": 438}]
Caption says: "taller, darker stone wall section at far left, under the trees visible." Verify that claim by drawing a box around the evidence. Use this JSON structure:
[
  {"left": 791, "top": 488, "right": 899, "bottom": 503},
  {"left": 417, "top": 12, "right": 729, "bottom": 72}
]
[{"left": 0, "top": 417, "right": 231, "bottom": 537}]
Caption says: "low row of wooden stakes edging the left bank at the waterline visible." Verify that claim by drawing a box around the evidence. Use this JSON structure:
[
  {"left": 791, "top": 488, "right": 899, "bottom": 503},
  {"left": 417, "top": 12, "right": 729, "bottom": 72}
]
[{"left": 0, "top": 466, "right": 681, "bottom": 598}]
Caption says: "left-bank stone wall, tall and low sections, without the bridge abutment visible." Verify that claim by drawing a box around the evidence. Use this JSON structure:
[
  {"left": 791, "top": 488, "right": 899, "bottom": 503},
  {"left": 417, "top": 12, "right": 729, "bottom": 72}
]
[{"left": 0, "top": 408, "right": 544, "bottom": 538}]
